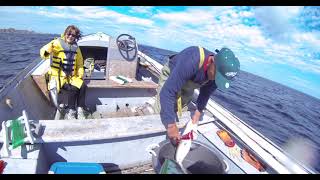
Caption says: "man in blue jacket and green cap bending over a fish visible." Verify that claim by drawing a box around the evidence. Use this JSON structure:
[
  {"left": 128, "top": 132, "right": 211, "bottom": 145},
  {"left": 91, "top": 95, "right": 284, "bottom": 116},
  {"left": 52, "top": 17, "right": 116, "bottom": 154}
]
[{"left": 155, "top": 46, "right": 240, "bottom": 143}]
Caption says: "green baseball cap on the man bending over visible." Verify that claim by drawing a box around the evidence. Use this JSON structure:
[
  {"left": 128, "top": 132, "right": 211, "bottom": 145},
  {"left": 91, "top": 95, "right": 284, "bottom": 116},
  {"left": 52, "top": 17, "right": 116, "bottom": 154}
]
[{"left": 214, "top": 48, "right": 240, "bottom": 91}]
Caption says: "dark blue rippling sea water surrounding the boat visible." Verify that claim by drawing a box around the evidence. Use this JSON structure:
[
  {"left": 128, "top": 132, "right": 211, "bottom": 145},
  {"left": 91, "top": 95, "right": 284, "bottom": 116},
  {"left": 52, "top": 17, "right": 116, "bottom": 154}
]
[{"left": 0, "top": 33, "right": 320, "bottom": 172}]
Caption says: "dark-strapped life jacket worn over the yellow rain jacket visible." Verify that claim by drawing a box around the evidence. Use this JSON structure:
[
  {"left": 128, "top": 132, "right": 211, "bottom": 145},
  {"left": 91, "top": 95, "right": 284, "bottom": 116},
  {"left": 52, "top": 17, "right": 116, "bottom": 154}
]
[{"left": 51, "top": 38, "right": 78, "bottom": 78}]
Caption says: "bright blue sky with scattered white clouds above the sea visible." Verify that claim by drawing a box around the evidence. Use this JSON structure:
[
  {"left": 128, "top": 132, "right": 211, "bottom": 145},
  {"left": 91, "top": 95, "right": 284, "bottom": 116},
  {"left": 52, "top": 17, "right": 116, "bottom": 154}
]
[{"left": 0, "top": 6, "right": 320, "bottom": 99}]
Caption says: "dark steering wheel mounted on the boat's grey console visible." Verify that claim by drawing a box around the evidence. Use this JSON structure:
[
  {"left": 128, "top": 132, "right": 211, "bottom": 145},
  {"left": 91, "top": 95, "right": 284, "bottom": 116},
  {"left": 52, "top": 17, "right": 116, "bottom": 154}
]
[{"left": 117, "top": 34, "right": 138, "bottom": 61}]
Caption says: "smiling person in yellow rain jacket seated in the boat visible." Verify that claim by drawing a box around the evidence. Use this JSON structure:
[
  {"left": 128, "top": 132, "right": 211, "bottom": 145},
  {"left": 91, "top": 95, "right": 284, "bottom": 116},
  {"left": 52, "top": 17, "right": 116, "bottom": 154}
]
[{"left": 40, "top": 25, "right": 86, "bottom": 119}]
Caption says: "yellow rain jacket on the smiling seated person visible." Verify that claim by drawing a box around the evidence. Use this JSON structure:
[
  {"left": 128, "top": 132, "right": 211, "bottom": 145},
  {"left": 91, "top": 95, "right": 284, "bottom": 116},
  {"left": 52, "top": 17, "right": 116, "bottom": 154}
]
[{"left": 40, "top": 37, "right": 84, "bottom": 92}]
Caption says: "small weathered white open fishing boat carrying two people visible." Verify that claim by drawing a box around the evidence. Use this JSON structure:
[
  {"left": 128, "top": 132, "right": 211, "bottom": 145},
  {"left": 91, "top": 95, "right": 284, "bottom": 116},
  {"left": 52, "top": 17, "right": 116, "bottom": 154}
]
[{"left": 0, "top": 33, "right": 317, "bottom": 174}]
